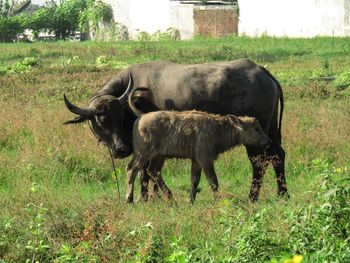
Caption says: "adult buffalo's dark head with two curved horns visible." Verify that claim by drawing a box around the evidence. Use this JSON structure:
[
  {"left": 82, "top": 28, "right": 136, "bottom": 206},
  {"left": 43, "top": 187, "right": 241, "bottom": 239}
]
[{"left": 64, "top": 79, "right": 133, "bottom": 158}]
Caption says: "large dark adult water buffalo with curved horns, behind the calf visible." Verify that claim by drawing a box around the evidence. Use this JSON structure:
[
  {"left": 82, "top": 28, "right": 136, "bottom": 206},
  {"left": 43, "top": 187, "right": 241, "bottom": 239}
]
[{"left": 65, "top": 59, "right": 288, "bottom": 201}]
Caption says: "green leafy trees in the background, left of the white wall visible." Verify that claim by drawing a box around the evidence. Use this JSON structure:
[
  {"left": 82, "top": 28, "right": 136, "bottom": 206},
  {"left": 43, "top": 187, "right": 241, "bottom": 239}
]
[{"left": 0, "top": 0, "right": 113, "bottom": 41}]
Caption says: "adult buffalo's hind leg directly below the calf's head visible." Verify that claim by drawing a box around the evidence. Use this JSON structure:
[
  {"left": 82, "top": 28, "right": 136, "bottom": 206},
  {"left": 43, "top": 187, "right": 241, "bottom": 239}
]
[{"left": 246, "top": 146, "right": 268, "bottom": 202}]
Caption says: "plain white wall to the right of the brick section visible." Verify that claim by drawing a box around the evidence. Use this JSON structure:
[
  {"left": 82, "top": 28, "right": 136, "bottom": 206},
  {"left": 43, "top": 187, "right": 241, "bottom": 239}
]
[{"left": 238, "top": 0, "right": 350, "bottom": 37}]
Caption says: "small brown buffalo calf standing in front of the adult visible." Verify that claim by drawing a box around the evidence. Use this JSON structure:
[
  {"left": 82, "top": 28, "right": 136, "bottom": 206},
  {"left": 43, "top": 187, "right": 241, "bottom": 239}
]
[{"left": 126, "top": 111, "right": 271, "bottom": 202}]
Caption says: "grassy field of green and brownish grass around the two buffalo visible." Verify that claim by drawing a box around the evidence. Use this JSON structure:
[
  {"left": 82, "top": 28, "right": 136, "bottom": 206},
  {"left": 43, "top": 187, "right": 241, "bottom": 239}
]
[{"left": 0, "top": 37, "right": 350, "bottom": 263}]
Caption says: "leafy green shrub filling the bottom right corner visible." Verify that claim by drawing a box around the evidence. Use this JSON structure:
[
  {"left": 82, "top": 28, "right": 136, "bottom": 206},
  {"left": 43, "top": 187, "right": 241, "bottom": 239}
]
[{"left": 289, "top": 170, "right": 350, "bottom": 262}]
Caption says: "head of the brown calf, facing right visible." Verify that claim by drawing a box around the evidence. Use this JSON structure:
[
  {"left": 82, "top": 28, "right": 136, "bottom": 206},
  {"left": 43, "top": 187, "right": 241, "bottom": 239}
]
[{"left": 237, "top": 117, "right": 271, "bottom": 148}]
